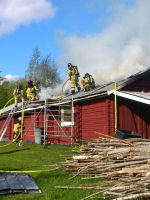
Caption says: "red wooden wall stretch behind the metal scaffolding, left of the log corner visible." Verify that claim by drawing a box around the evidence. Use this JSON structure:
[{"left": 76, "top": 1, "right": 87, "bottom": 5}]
[{"left": 0, "top": 107, "right": 74, "bottom": 143}]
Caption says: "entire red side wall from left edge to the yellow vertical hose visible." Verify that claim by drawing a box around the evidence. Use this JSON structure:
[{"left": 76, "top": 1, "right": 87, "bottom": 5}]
[{"left": 0, "top": 96, "right": 115, "bottom": 143}]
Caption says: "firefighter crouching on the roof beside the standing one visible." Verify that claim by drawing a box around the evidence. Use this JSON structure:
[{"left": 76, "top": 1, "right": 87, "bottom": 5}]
[{"left": 81, "top": 73, "right": 95, "bottom": 92}]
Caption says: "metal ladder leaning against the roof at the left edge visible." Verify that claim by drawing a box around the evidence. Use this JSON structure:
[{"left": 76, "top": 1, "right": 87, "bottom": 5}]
[{"left": 0, "top": 108, "right": 15, "bottom": 141}]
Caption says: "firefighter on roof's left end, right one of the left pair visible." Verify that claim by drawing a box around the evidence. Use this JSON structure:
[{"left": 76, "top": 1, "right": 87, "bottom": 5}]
[{"left": 26, "top": 80, "right": 39, "bottom": 101}]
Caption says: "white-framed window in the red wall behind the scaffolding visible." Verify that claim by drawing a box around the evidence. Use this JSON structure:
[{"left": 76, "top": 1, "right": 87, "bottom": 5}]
[{"left": 61, "top": 105, "right": 74, "bottom": 126}]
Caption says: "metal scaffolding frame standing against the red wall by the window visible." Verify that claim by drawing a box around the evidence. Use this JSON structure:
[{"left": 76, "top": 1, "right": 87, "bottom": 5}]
[{"left": 22, "top": 98, "right": 74, "bottom": 145}]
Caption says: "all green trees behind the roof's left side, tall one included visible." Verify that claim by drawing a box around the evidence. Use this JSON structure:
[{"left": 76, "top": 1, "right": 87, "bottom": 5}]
[{"left": 0, "top": 48, "right": 60, "bottom": 109}]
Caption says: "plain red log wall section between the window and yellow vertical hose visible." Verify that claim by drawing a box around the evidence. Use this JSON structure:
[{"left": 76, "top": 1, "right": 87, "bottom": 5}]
[{"left": 75, "top": 97, "right": 114, "bottom": 139}]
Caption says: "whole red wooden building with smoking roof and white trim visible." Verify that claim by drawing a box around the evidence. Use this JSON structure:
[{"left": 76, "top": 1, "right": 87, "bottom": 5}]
[{"left": 0, "top": 69, "right": 150, "bottom": 143}]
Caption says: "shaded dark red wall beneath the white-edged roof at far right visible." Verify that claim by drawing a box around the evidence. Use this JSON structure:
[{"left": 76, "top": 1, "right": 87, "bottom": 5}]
[{"left": 118, "top": 97, "right": 150, "bottom": 139}]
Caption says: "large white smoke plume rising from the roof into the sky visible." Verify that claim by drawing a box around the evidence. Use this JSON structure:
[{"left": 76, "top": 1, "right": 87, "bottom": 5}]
[{"left": 58, "top": 0, "right": 150, "bottom": 83}]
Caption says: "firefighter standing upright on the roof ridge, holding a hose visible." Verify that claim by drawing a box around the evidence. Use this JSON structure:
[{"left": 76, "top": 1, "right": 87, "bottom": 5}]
[{"left": 68, "top": 63, "right": 81, "bottom": 94}]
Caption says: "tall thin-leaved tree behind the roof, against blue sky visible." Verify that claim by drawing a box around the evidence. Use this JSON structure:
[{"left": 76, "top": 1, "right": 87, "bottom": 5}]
[{"left": 25, "top": 48, "right": 61, "bottom": 88}]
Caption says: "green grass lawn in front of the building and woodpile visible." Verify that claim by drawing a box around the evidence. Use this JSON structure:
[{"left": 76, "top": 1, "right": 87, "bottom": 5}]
[{"left": 0, "top": 142, "right": 100, "bottom": 200}]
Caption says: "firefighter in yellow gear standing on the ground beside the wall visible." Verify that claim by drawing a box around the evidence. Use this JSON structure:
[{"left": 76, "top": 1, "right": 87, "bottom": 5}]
[{"left": 13, "top": 117, "right": 22, "bottom": 142}]
